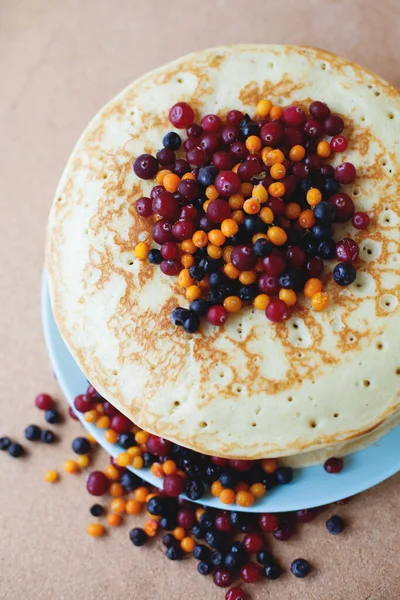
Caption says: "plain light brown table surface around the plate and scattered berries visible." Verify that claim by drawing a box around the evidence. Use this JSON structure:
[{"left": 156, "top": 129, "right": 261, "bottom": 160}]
[{"left": 0, "top": 0, "right": 400, "bottom": 600}]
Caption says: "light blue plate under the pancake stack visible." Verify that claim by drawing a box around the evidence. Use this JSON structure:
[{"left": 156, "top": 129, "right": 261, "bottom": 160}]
[{"left": 42, "top": 275, "right": 400, "bottom": 512}]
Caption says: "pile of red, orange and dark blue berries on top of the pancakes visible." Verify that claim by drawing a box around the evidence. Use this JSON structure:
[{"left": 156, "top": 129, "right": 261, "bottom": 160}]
[{"left": 133, "top": 100, "right": 369, "bottom": 333}]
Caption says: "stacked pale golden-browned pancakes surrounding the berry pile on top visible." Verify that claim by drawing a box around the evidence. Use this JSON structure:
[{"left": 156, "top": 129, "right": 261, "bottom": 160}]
[{"left": 46, "top": 45, "right": 400, "bottom": 459}]
